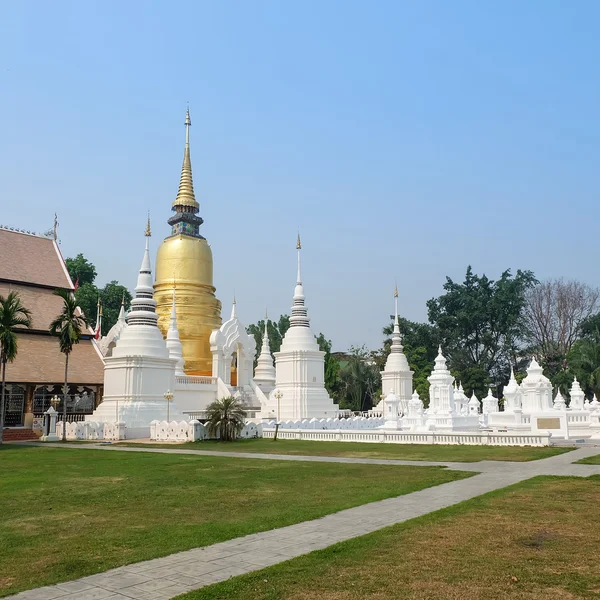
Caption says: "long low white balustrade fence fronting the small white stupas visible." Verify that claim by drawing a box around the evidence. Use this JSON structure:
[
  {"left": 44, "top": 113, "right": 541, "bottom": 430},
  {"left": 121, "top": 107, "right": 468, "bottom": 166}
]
[{"left": 262, "top": 424, "right": 550, "bottom": 446}]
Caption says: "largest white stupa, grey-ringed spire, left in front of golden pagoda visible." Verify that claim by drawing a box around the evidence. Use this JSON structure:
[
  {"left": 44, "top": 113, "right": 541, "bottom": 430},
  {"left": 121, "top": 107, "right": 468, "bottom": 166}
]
[{"left": 86, "top": 221, "right": 184, "bottom": 438}]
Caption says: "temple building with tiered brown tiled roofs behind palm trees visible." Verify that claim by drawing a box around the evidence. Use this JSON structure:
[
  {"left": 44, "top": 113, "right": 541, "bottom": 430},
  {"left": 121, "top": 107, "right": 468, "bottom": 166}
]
[{"left": 0, "top": 226, "right": 104, "bottom": 440}]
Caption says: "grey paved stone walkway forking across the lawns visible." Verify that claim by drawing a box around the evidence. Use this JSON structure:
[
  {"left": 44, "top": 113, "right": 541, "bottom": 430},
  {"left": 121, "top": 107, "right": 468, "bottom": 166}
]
[{"left": 11, "top": 444, "right": 600, "bottom": 600}]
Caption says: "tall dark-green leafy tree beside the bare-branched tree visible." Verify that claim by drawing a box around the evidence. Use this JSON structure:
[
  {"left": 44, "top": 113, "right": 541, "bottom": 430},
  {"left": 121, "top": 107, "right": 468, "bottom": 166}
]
[{"left": 427, "top": 266, "right": 537, "bottom": 397}]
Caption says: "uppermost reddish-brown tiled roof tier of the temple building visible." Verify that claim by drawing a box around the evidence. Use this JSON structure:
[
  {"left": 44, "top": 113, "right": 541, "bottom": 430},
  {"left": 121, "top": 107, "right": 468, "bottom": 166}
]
[{"left": 0, "top": 229, "right": 73, "bottom": 289}]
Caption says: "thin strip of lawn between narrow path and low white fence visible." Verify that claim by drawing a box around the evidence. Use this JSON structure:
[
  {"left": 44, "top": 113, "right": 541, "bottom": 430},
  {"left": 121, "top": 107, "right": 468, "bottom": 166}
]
[{"left": 113, "top": 438, "right": 573, "bottom": 462}]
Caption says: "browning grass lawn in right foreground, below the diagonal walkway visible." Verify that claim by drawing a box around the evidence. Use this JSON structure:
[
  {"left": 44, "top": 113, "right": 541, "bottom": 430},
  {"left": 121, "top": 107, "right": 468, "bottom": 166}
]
[{"left": 180, "top": 477, "right": 600, "bottom": 600}]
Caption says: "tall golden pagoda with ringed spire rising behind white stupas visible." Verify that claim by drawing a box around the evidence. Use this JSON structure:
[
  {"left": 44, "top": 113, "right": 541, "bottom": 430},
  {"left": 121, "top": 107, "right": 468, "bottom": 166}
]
[{"left": 154, "top": 109, "right": 221, "bottom": 375}]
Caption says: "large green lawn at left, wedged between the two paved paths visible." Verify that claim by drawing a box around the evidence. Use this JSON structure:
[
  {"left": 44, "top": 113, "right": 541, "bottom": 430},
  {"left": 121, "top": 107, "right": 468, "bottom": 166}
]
[{"left": 0, "top": 445, "right": 470, "bottom": 596}]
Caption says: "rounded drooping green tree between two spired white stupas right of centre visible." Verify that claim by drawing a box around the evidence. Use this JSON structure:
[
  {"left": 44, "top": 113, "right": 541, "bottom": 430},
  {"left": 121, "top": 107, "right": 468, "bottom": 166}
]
[{"left": 339, "top": 346, "right": 381, "bottom": 411}]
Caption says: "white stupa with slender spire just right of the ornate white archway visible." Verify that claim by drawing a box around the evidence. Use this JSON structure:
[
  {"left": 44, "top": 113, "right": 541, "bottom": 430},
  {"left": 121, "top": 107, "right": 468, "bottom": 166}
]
[{"left": 262, "top": 235, "right": 338, "bottom": 420}]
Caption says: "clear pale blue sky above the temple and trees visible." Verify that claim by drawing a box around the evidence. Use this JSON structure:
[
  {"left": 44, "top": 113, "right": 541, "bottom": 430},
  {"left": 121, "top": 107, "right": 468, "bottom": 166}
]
[{"left": 0, "top": 0, "right": 600, "bottom": 350}]
